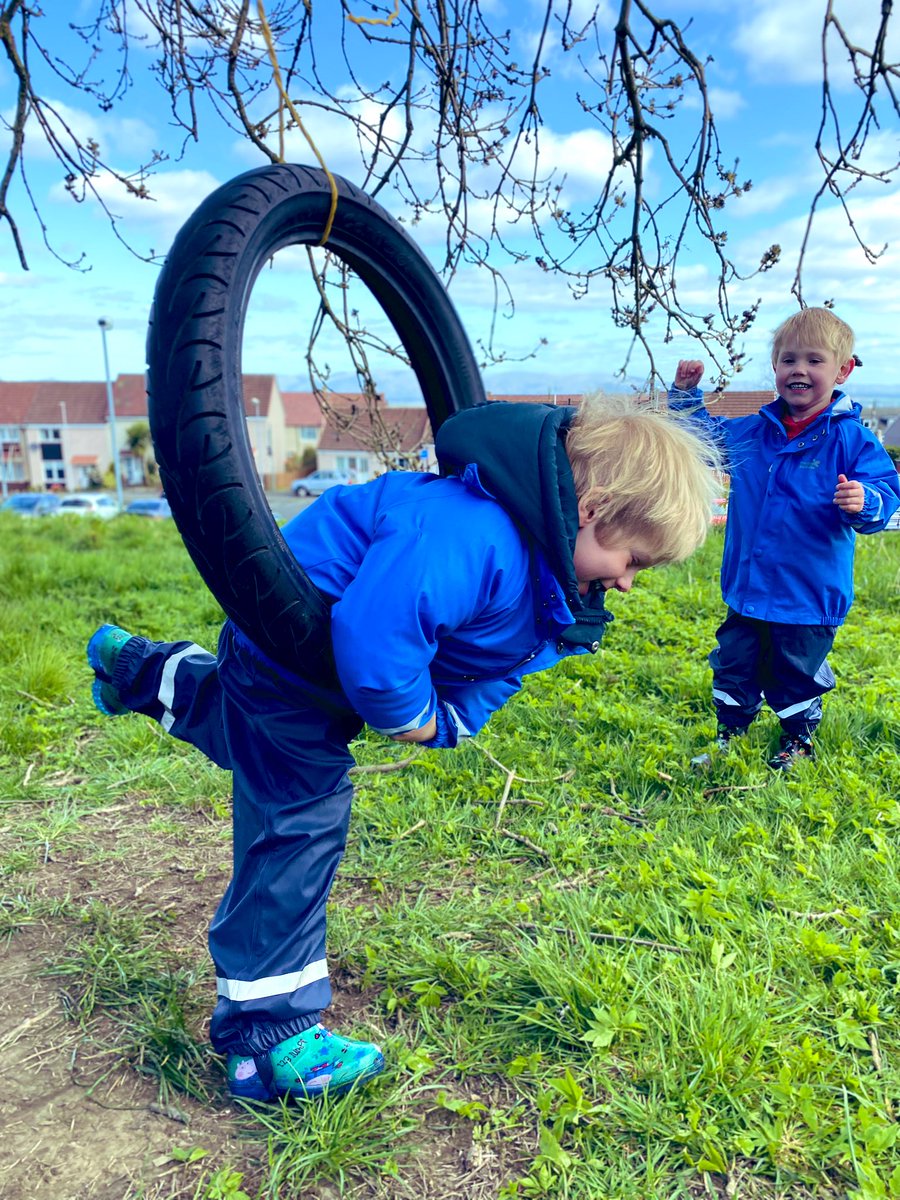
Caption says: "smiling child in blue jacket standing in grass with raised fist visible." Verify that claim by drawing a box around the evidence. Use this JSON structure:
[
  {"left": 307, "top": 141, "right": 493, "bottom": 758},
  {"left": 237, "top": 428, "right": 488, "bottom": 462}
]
[{"left": 668, "top": 308, "right": 900, "bottom": 770}]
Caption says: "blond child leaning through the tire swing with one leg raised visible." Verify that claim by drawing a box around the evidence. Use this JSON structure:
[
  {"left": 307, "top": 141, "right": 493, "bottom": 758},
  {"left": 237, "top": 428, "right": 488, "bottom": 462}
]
[{"left": 88, "top": 402, "right": 715, "bottom": 1100}]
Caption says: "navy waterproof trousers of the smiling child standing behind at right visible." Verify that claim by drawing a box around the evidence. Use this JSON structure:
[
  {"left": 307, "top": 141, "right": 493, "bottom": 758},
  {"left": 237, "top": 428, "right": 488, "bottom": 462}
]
[{"left": 709, "top": 608, "right": 836, "bottom": 737}]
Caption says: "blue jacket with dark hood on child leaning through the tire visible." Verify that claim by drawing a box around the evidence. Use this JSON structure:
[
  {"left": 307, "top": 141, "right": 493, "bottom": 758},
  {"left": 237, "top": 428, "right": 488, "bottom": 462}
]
[{"left": 267, "top": 403, "right": 611, "bottom": 745}]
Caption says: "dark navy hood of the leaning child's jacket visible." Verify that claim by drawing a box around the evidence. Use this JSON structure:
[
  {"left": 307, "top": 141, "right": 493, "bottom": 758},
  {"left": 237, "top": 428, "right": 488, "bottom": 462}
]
[{"left": 434, "top": 401, "right": 612, "bottom": 650}]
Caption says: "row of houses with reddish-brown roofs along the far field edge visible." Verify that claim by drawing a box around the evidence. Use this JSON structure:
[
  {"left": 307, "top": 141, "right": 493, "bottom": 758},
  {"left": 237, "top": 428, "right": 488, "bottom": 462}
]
[{"left": 0, "top": 374, "right": 900, "bottom": 494}]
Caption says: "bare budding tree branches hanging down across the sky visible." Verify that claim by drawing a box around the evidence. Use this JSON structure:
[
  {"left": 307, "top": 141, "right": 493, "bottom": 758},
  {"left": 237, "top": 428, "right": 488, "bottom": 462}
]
[{"left": 0, "top": 0, "right": 900, "bottom": 393}]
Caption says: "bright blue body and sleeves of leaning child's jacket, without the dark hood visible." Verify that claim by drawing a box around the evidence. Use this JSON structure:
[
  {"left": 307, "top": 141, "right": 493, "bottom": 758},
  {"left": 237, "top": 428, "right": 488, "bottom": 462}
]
[{"left": 283, "top": 468, "right": 572, "bottom": 738}]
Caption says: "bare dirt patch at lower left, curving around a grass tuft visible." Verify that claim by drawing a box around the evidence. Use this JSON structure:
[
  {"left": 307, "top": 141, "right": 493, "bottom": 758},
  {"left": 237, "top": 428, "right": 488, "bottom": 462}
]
[{"left": 0, "top": 799, "right": 264, "bottom": 1200}]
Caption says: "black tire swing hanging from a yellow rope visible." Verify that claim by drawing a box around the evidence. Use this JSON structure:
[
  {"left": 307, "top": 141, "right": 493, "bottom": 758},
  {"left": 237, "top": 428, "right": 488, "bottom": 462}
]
[{"left": 146, "top": 164, "right": 485, "bottom": 685}]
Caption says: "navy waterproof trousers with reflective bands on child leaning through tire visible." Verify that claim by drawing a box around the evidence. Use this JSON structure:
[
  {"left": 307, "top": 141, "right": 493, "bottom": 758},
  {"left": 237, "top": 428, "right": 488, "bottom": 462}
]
[{"left": 113, "top": 623, "right": 361, "bottom": 1055}]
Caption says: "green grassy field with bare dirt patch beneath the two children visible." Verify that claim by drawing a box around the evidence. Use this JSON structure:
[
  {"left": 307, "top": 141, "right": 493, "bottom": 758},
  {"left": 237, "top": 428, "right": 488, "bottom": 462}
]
[{"left": 0, "top": 518, "right": 900, "bottom": 1200}]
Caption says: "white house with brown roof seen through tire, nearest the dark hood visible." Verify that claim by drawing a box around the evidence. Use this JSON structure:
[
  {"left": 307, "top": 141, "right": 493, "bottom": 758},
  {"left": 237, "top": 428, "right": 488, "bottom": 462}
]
[{"left": 316, "top": 397, "right": 437, "bottom": 482}]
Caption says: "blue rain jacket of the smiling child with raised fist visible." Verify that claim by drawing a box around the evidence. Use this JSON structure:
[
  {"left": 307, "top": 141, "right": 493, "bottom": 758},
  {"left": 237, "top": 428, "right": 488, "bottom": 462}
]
[{"left": 668, "top": 388, "right": 900, "bottom": 625}]
